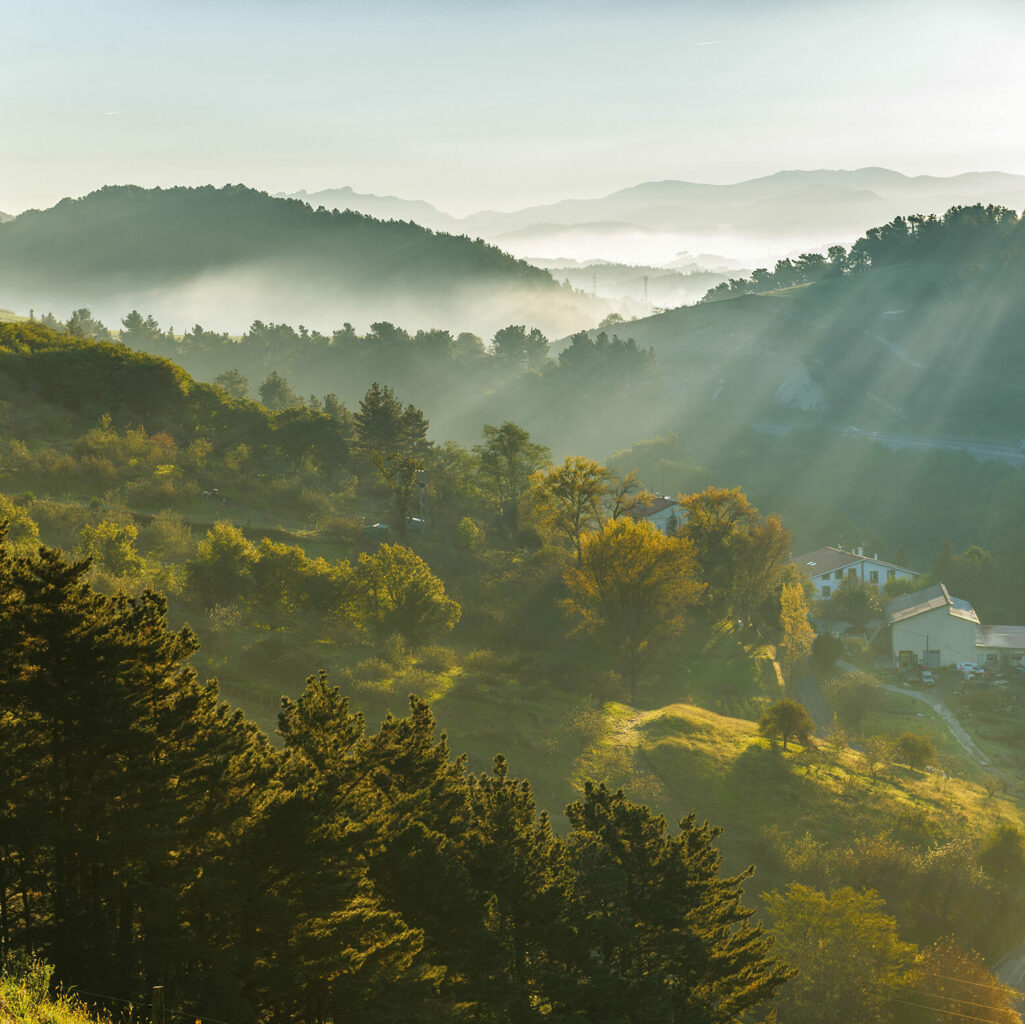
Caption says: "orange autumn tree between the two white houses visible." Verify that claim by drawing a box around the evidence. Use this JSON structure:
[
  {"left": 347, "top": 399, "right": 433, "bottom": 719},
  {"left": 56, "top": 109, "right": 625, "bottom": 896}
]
[{"left": 680, "top": 487, "right": 790, "bottom": 623}]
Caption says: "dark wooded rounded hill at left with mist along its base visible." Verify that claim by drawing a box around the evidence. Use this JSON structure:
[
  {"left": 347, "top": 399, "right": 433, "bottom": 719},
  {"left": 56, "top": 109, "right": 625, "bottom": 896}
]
[{"left": 0, "top": 186, "right": 608, "bottom": 334}]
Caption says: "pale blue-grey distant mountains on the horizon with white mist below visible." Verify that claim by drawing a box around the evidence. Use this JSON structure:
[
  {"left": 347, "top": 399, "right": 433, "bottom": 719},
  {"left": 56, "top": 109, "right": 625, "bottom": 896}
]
[{"left": 282, "top": 167, "right": 1025, "bottom": 270}]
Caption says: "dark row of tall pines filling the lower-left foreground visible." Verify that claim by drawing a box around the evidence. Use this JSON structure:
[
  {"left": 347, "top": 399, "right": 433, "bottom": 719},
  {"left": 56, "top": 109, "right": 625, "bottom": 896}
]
[{"left": 0, "top": 546, "right": 789, "bottom": 1022}]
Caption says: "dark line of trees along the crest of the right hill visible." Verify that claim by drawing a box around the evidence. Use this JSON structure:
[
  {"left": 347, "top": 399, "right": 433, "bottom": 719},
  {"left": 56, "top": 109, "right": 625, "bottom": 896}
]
[{"left": 701, "top": 204, "right": 1025, "bottom": 302}]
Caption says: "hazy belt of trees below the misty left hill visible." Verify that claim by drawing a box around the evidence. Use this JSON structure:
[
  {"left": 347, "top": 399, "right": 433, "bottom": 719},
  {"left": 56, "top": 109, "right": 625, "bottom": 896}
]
[{"left": 28, "top": 310, "right": 663, "bottom": 448}]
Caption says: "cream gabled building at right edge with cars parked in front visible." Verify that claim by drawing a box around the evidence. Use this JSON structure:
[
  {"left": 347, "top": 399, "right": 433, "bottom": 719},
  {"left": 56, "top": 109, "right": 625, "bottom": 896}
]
[{"left": 887, "top": 583, "right": 1025, "bottom": 668}]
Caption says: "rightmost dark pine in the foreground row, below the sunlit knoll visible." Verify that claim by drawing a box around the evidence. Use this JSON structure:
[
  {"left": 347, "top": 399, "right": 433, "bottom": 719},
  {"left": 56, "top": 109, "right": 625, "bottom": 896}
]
[{"left": 560, "top": 782, "right": 790, "bottom": 1024}]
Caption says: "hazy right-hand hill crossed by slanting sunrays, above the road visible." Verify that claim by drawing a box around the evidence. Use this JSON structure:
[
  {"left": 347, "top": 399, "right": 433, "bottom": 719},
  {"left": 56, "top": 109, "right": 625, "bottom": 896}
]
[{"left": 590, "top": 207, "right": 1025, "bottom": 443}]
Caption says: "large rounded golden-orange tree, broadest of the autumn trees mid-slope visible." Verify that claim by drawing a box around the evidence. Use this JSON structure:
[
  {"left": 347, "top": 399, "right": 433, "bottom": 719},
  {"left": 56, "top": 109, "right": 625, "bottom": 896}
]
[{"left": 565, "top": 518, "right": 701, "bottom": 696}]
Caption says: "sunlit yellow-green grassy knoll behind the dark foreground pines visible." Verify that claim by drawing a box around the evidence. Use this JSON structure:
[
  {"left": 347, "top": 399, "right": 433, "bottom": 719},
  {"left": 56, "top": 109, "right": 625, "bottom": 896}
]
[{"left": 574, "top": 703, "right": 1022, "bottom": 875}]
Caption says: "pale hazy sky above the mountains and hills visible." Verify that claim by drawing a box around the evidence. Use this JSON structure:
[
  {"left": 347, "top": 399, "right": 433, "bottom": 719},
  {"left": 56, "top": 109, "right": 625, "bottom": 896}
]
[{"left": 0, "top": 0, "right": 1025, "bottom": 214}]
